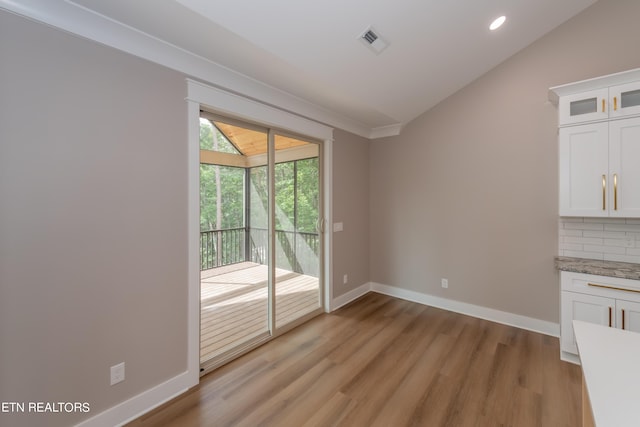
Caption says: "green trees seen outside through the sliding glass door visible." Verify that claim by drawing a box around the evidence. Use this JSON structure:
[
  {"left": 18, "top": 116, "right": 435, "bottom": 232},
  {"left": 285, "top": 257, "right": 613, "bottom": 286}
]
[{"left": 200, "top": 119, "right": 319, "bottom": 268}]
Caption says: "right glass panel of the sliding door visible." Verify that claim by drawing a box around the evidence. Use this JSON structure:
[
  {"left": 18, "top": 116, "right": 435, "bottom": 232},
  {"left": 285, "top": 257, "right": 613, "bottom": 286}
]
[{"left": 274, "top": 134, "right": 322, "bottom": 328}]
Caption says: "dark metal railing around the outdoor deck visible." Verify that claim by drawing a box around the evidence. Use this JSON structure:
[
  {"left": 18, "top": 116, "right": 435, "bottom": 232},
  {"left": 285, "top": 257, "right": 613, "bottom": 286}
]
[{"left": 200, "top": 228, "right": 320, "bottom": 277}]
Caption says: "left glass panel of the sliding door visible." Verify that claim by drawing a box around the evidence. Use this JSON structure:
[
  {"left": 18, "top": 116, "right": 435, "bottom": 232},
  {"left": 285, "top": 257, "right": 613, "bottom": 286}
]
[{"left": 200, "top": 117, "right": 269, "bottom": 366}]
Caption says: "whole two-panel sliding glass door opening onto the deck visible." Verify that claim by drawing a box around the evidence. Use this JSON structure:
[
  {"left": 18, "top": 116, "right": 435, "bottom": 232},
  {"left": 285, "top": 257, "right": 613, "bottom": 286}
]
[{"left": 200, "top": 113, "right": 322, "bottom": 369}]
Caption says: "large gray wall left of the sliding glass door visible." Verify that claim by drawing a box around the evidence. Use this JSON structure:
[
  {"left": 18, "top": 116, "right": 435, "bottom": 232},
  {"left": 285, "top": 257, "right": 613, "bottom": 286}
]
[{"left": 0, "top": 12, "right": 187, "bottom": 426}]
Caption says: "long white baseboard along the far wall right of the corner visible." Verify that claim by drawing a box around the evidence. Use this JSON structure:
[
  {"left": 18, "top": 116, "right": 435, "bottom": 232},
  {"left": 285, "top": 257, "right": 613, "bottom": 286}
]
[{"left": 370, "top": 283, "right": 560, "bottom": 337}]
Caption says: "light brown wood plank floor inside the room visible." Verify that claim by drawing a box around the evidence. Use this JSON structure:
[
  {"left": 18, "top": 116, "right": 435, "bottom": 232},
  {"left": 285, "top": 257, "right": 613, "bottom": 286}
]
[{"left": 131, "top": 293, "right": 581, "bottom": 427}]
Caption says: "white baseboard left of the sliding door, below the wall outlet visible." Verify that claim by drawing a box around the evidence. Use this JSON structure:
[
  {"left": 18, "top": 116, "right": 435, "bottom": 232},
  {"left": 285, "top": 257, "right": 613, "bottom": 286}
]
[{"left": 76, "top": 372, "right": 195, "bottom": 427}]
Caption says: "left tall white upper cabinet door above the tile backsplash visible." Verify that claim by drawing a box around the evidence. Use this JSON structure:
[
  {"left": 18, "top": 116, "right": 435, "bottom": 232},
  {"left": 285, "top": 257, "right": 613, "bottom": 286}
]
[{"left": 559, "top": 123, "right": 609, "bottom": 216}]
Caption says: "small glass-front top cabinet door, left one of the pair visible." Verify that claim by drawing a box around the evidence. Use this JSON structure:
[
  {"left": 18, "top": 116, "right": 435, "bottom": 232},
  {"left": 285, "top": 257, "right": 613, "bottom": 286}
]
[{"left": 558, "top": 88, "right": 609, "bottom": 125}]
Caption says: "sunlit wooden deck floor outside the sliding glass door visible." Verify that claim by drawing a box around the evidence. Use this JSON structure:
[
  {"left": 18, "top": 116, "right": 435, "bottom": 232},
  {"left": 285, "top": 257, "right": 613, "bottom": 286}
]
[{"left": 200, "top": 262, "right": 320, "bottom": 363}]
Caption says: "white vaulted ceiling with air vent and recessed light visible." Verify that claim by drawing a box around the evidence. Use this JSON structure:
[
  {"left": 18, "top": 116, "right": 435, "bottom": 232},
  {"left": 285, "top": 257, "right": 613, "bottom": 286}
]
[{"left": 0, "top": 0, "right": 595, "bottom": 136}]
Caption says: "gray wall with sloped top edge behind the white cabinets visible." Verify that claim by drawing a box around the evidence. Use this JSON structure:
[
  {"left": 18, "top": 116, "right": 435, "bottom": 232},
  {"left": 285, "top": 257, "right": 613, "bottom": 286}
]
[{"left": 370, "top": 0, "right": 640, "bottom": 322}]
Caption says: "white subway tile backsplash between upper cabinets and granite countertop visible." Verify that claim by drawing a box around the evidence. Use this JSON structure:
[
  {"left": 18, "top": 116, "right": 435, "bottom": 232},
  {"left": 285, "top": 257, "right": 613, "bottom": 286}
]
[{"left": 559, "top": 217, "right": 640, "bottom": 263}]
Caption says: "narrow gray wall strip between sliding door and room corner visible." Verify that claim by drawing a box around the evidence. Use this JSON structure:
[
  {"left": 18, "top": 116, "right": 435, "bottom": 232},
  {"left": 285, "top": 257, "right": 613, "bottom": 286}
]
[{"left": 333, "top": 129, "right": 370, "bottom": 298}]
